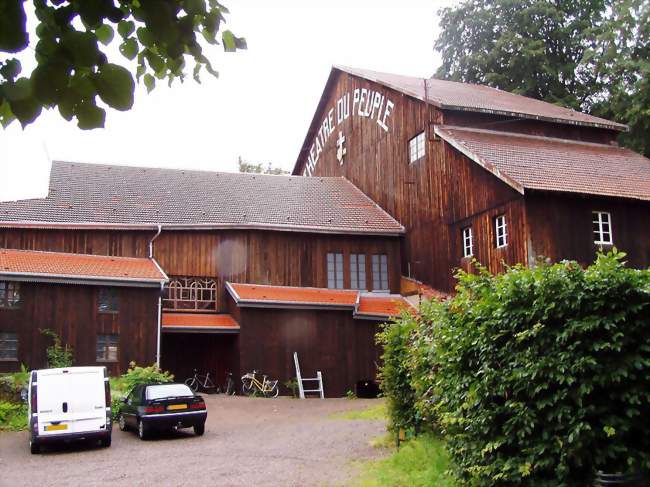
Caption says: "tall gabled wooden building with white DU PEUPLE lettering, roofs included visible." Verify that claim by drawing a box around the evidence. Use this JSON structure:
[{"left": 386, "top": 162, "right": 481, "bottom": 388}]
[{"left": 293, "top": 67, "right": 650, "bottom": 292}]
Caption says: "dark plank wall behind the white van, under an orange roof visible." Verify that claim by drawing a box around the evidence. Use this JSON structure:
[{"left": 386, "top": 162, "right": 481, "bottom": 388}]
[{"left": 0, "top": 282, "right": 160, "bottom": 375}]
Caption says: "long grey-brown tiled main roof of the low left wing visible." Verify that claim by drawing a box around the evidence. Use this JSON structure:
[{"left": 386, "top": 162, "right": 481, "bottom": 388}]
[{"left": 0, "top": 161, "right": 404, "bottom": 235}]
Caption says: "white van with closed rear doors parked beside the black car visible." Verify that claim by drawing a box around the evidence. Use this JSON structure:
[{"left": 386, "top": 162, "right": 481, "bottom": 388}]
[{"left": 28, "top": 367, "right": 112, "bottom": 453}]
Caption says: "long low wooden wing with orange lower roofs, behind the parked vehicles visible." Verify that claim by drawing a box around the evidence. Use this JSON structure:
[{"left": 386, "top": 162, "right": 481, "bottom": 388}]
[{"left": 0, "top": 162, "right": 409, "bottom": 396}]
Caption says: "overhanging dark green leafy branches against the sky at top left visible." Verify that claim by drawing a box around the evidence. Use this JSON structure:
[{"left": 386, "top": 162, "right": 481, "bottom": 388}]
[{"left": 0, "top": 0, "right": 246, "bottom": 129}]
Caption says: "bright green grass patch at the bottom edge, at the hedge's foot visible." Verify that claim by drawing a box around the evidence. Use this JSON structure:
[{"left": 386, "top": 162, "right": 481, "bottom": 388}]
[{"left": 353, "top": 435, "right": 456, "bottom": 487}]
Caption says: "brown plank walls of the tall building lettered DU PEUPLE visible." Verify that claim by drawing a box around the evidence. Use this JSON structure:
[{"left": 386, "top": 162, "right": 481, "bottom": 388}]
[{"left": 294, "top": 71, "right": 650, "bottom": 292}]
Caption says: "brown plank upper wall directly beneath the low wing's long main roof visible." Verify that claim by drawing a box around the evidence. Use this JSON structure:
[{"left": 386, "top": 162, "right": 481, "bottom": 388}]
[{"left": 0, "top": 229, "right": 400, "bottom": 312}]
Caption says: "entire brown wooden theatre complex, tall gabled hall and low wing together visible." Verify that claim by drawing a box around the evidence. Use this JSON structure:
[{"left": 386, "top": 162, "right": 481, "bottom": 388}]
[{"left": 0, "top": 67, "right": 650, "bottom": 396}]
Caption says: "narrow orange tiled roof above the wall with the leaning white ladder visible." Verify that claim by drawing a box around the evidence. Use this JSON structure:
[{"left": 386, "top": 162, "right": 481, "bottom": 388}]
[{"left": 226, "top": 282, "right": 359, "bottom": 307}]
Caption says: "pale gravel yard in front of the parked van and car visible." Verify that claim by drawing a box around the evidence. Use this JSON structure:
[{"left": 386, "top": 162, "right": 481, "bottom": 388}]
[{"left": 0, "top": 395, "right": 385, "bottom": 487}]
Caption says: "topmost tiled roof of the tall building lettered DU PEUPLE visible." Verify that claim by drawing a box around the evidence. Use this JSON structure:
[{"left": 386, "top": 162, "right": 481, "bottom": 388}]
[{"left": 333, "top": 66, "right": 627, "bottom": 130}]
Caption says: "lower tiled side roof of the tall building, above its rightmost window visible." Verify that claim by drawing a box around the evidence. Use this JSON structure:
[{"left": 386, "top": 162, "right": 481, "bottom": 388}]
[{"left": 436, "top": 126, "right": 650, "bottom": 200}]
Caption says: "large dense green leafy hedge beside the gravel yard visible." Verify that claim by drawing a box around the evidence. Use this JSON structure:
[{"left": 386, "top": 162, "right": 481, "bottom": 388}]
[{"left": 382, "top": 251, "right": 650, "bottom": 487}]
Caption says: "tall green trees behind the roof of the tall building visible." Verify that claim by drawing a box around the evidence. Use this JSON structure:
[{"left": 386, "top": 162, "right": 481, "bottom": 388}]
[{"left": 435, "top": 0, "right": 650, "bottom": 156}]
